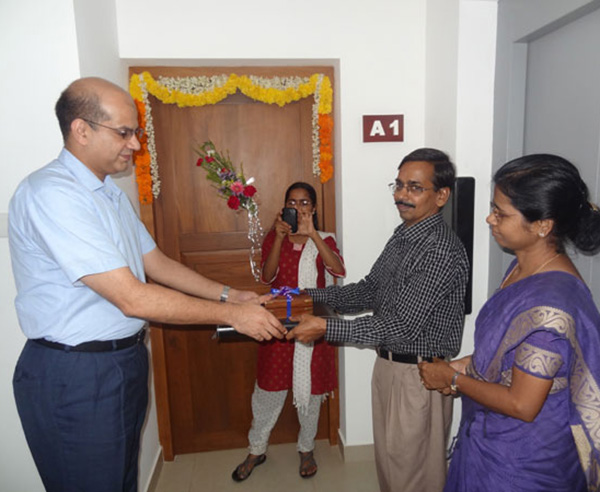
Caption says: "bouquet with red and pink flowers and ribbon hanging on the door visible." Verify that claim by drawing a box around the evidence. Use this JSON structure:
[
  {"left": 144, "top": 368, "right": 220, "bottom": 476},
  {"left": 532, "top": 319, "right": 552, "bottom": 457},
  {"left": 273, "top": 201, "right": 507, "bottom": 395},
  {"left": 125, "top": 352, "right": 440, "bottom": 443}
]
[{"left": 194, "top": 140, "right": 263, "bottom": 282}]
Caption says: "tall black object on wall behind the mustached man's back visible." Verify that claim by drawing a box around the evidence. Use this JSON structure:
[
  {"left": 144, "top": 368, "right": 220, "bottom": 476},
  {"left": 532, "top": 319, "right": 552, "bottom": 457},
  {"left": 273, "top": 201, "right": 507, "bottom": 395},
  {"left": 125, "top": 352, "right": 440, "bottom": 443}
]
[{"left": 442, "top": 177, "right": 475, "bottom": 314}]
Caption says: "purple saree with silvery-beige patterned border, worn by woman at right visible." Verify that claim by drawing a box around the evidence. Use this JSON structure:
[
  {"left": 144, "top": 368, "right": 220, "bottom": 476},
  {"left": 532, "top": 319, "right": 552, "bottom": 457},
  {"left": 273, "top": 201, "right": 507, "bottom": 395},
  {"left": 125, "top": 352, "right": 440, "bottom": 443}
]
[{"left": 444, "top": 272, "right": 600, "bottom": 492}]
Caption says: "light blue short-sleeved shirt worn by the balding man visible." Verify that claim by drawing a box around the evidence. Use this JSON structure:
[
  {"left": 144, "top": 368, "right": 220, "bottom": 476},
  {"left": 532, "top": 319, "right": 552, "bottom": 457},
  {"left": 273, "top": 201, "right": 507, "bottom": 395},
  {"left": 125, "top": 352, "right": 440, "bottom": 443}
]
[{"left": 8, "top": 149, "right": 156, "bottom": 345}]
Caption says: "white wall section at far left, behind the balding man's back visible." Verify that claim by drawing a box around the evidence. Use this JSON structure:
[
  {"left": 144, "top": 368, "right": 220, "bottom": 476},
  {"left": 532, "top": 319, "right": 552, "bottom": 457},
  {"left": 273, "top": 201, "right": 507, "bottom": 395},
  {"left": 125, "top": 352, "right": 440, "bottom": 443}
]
[{"left": 0, "top": 0, "right": 79, "bottom": 492}]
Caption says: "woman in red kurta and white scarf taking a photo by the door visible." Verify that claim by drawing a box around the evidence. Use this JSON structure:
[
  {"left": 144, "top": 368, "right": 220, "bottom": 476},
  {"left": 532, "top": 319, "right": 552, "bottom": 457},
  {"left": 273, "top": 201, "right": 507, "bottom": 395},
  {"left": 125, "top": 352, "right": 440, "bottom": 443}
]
[{"left": 232, "top": 182, "right": 346, "bottom": 481}]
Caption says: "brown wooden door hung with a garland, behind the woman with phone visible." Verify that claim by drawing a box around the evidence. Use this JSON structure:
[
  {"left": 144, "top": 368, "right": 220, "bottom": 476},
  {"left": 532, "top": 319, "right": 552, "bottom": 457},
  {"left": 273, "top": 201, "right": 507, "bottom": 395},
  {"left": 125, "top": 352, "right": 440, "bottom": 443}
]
[{"left": 132, "top": 67, "right": 339, "bottom": 459}]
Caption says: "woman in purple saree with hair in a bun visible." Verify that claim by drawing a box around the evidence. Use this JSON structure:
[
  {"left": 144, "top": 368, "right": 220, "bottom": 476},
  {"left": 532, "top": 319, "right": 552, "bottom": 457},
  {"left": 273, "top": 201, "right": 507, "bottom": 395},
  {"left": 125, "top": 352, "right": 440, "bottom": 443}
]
[{"left": 420, "top": 154, "right": 600, "bottom": 492}]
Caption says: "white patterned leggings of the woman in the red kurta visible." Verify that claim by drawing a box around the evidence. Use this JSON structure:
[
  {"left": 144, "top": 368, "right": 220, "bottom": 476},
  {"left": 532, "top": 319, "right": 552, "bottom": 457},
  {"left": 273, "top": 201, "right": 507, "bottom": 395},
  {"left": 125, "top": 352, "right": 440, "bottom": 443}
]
[{"left": 248, "top": 383, "right": 325, "bottom": 455}]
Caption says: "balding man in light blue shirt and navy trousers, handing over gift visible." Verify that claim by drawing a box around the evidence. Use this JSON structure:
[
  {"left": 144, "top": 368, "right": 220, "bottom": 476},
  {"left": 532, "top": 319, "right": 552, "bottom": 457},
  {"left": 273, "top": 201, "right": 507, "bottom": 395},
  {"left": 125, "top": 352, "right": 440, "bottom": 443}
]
[{"left": 9, "top": 78, "right": 284, "bottom": 492}]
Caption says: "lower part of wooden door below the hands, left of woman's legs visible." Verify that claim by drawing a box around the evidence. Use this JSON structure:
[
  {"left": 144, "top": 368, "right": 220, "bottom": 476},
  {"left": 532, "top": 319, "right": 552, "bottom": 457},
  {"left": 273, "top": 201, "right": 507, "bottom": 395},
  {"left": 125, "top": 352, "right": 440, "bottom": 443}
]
[{"left": 167, "top": 327, "right": 256, "bottom": 454}]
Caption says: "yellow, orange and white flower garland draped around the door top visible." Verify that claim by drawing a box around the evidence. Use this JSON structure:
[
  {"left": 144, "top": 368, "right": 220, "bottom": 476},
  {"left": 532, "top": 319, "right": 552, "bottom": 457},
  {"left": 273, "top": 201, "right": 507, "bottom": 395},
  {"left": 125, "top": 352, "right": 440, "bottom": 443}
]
[{"left": 129, "top": 72, "right": 333, "bottom": 204}]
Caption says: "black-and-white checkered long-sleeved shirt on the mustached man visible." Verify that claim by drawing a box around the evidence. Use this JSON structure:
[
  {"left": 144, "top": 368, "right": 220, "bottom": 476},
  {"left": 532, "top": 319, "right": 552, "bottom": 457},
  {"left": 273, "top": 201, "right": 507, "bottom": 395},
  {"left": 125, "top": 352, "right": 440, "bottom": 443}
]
[{"left": 307, "top": 213, "right": 469, "bottom": 357}]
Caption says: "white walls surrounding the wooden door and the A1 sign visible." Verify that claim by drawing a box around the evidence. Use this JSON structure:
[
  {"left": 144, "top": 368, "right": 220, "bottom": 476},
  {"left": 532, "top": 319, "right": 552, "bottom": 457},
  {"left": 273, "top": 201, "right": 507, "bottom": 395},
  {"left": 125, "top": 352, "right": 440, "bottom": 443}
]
[{"left": 0, "top": 0, "right": 496, "bottom": 486}]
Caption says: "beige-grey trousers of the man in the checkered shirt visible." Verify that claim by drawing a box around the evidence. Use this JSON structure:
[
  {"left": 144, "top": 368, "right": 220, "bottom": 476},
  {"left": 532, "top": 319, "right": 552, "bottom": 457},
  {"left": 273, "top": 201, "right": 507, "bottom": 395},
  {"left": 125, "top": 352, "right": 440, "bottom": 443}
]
[{"left": 371, "top": 357, "right": 452, "bottom": 492}]
